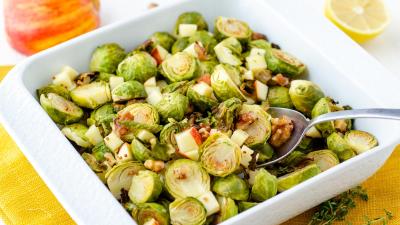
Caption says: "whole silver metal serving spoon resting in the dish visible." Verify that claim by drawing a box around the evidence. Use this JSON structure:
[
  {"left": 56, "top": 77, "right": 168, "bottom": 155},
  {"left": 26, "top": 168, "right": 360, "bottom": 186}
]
[{"left": 257, "top": 107, "right": 400, "bottom": 167}]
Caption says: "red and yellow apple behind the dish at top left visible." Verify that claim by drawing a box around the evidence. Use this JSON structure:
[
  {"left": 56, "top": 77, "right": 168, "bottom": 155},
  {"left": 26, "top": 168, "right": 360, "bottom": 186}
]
[{"left": 4, "top": 0, "right": 100, "bottom": 55}]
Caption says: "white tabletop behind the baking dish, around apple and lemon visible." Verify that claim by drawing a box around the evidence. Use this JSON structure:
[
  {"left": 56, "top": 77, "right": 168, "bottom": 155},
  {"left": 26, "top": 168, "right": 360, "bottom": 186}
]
[{"left": 0, "top": 0, "right": 400, "bottom": 225}]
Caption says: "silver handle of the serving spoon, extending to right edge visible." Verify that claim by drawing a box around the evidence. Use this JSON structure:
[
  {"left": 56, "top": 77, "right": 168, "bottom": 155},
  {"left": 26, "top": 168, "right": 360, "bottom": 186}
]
[{"left": 308, "top": 108, "right": 400, "bottom": 127}]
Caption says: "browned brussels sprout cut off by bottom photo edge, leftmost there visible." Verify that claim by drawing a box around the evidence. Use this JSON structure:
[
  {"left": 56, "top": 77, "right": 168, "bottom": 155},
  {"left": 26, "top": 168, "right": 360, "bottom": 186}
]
[{"left": 132, "top": 203, "right": 169, "bottom": 225}]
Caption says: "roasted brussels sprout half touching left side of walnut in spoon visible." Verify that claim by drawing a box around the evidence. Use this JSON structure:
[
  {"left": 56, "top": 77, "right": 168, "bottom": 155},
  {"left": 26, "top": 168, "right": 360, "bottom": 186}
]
[{"left": 236, "top": 104, "right": 271, "bottom": 148}]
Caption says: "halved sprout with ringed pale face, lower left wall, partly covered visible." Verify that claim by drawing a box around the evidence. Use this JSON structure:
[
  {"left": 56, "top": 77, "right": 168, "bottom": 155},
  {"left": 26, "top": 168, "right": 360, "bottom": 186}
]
[{"left": 105, "top": 162, "right": 146, "bottom": 199}]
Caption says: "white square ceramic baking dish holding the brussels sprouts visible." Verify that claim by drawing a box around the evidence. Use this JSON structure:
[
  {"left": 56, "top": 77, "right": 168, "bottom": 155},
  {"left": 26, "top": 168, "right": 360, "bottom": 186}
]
[{"left": 0, "top": 0, "right": 400, "bottom": 225}]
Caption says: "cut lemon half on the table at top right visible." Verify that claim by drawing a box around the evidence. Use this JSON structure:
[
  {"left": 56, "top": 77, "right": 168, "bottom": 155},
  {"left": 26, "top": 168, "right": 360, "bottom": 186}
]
[{"left": 325, "top": 0, "right": 389, "bottom": 43}]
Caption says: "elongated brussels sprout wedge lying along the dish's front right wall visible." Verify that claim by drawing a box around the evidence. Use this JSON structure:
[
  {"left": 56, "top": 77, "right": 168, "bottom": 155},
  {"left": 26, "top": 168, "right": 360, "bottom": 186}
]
[{"left": 278, "top": 164, "right": 321, "bottom": 192}]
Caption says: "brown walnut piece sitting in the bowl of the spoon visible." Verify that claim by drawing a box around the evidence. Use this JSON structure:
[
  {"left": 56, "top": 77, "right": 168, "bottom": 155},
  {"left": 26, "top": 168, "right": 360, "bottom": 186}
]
[{"left": 269, "top": 116, "right": 294, "bottom": 147}]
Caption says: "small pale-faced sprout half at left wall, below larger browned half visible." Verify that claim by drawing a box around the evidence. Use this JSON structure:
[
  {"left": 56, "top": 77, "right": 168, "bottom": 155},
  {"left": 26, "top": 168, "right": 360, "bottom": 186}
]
[{"left": 61, "top": 123, "right": 92, "bottom": 148}]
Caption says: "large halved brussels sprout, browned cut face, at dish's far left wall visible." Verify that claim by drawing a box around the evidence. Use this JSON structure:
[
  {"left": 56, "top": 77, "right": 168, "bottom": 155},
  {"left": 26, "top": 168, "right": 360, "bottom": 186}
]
[{"left": 40, "top": 93, "right": 83, "bottom": 125}]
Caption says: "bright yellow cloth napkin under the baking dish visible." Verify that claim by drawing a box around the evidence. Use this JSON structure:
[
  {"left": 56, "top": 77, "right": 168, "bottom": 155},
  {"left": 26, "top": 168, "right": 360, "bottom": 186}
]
[{"left": 0, "top": 67, "right": 400, "bottom": 225}]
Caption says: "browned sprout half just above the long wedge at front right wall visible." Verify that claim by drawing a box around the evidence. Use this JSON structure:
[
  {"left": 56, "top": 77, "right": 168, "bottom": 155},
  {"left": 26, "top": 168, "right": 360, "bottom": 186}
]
[{"left": 307, "top": 150, "right": 340, "bottom": 172}]
